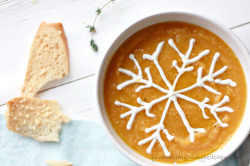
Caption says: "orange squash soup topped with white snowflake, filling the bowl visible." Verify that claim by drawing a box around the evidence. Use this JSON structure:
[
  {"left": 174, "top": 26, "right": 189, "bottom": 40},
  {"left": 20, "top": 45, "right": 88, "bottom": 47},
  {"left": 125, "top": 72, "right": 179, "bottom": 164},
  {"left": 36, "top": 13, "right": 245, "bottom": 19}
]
[{"left": 104, "top": 22, "right": 246, "bottom": 163}]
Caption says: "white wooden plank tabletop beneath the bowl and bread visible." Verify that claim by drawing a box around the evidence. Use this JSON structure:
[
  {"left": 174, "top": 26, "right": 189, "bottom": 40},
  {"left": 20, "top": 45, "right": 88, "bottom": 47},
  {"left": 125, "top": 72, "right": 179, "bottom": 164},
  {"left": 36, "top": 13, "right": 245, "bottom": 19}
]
[{"left": 0, "top": 0, "right": 250, "bottom": 165}]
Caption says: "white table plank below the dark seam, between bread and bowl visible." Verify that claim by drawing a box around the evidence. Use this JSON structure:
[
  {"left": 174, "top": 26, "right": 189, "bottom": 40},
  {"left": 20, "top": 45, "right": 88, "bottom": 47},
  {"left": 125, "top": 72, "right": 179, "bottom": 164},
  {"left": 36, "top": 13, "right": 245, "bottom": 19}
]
[{"left": 0, "top": 76, "right": 99, "bottom": 121}]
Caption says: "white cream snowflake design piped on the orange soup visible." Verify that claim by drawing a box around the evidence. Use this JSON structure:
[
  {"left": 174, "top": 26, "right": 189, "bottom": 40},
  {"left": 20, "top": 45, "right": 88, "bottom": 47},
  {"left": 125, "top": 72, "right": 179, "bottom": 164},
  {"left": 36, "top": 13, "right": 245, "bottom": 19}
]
[{"left": 115, "top": 39, "right": 237, "bottom": 156}]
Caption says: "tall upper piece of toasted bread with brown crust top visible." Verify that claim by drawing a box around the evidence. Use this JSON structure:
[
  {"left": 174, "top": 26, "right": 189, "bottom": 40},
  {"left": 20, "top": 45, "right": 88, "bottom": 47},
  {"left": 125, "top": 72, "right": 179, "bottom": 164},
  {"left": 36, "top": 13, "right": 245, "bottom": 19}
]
[{"left": 21, "top": 22, "right": 69, "bottom": 96}]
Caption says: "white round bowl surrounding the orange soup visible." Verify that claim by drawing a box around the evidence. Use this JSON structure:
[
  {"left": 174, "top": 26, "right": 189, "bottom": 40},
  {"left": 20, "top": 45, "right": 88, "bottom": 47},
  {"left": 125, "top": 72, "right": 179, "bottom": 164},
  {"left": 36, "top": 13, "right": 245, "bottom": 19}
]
[{"left": 96, "top": 12, "right": 250, "bottom": 166}]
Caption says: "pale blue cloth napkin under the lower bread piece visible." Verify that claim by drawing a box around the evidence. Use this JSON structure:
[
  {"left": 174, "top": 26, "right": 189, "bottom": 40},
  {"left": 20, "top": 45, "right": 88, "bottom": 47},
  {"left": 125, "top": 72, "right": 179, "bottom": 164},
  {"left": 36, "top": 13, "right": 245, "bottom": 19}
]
[{"left": 0, "top": 115, "right": 242, "bottom": 166}]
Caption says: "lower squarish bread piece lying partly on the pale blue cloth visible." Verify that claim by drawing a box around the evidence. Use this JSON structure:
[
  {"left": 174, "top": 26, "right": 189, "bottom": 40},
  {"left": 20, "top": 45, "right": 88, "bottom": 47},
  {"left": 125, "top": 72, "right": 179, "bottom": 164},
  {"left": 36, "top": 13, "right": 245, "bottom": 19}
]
[{"left": 5, "top": 96, "right": 70, "bottom": 142}]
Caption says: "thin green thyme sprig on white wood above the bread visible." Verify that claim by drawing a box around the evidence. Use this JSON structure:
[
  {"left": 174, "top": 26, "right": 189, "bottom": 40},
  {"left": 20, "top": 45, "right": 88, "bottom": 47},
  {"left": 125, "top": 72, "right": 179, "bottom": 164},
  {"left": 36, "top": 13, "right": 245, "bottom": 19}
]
[{"left": 86, "top": 0, "right": 115, "bottom": 52}]
